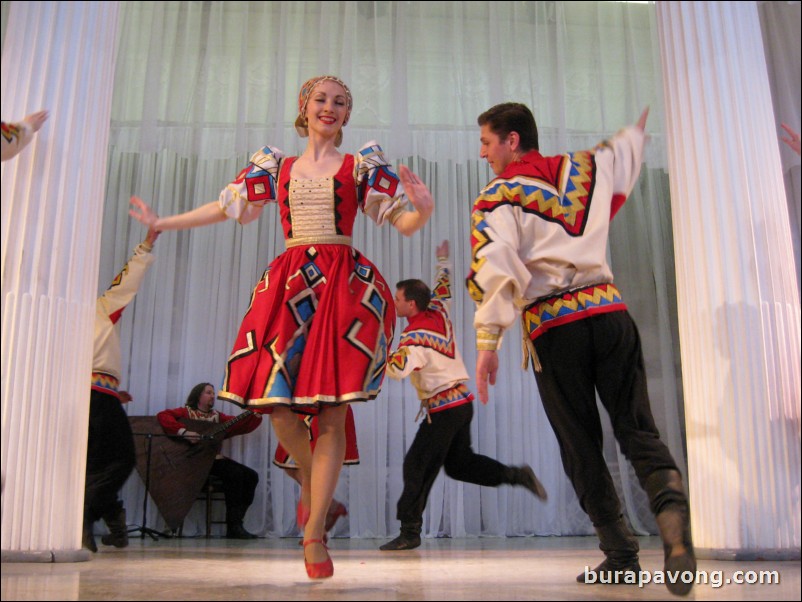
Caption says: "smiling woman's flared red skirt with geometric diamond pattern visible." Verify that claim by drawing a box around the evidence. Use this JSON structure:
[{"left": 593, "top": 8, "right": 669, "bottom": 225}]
[{"left": 218, "top": 244, "right": 395, "bottom": 415}]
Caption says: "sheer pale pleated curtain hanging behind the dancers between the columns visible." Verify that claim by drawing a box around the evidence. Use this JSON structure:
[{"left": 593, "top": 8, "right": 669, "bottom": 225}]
[{"left": 100, "top": 2, "right": 685, "bottom": 537}]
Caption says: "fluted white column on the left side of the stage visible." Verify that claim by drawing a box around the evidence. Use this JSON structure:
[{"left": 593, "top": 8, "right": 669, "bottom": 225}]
[{"left": 0, "top": 2, "right": 119, "bottom": 561}]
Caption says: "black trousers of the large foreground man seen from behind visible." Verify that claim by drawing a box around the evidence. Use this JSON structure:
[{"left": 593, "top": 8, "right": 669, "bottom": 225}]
[{"left": 535, "top": 311, "right": 677, "bottom": 527}]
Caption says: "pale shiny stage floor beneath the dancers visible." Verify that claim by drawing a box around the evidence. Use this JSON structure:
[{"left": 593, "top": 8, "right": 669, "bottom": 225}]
[{"left": 1, "top": 537, "right": 800, "bottom": 601}]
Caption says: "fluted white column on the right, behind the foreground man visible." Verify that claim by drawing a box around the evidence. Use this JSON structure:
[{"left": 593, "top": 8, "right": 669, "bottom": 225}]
[{"left": 657, "top": 2, "right": 800, "bottom": 558}]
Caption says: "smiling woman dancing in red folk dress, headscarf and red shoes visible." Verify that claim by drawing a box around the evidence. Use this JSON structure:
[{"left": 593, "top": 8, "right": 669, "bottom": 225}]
[{"left": 131, "top": 75, "right": 434, "bottom": 578}]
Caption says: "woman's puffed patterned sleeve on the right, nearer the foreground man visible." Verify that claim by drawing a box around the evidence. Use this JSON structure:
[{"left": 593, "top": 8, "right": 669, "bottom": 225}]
[{"left": 354, "top": 140, "right": 408, "bottom": 226}]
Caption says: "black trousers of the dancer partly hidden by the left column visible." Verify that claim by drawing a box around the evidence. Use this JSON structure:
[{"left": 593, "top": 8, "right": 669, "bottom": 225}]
[{"left": 84, "top": 391, "right": 136, "bottom": 522}]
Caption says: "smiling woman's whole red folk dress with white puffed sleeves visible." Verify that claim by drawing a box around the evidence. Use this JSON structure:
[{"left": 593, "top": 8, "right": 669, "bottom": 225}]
[{"left": 218, "top": 142, "right": 407, "bottom": 414}]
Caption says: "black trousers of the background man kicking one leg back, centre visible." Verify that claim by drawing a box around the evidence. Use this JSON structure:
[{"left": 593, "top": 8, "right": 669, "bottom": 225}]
[{"left": 397, "top": 403, "right": 509, "bottom": 523}]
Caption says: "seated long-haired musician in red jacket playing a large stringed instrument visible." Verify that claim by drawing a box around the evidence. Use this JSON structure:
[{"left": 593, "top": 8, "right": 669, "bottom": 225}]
[{"left": 156, "top": 383, "right": 262, "bottom": 539}]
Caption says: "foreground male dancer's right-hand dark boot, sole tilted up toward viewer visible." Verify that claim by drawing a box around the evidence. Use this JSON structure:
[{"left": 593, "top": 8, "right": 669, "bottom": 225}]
[{"left": 646, "top": 469, "right": 696, "bottom": 596}]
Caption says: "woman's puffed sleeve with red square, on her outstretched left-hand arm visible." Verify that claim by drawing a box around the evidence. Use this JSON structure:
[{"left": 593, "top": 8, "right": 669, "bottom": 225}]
[{"left": 219, "top": 146, "right": 284, "bottom": 224}]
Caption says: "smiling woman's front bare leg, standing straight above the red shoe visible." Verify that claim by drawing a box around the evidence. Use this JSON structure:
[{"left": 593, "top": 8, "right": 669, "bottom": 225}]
[{"left": 304, "top": 404, "right": 348, "bottom": 563}]
